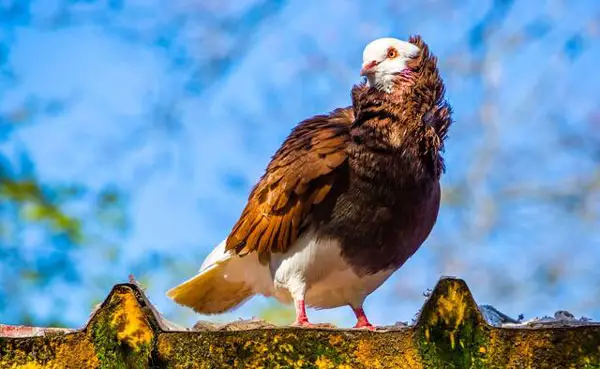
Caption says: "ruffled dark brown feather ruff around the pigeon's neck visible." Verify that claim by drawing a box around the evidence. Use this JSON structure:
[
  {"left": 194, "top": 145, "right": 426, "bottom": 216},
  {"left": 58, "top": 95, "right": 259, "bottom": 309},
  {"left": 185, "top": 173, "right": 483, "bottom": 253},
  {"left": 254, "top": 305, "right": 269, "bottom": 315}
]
[{"left": 352, "top": 36, "right": 452, "bottom": 177}]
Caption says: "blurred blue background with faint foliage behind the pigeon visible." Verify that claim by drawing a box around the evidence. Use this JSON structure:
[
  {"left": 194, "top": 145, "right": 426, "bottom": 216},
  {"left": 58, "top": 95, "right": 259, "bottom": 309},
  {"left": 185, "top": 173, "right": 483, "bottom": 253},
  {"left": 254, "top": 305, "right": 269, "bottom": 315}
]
[{"left": 0, "top": 0, "right": 600, "bottom": 327}]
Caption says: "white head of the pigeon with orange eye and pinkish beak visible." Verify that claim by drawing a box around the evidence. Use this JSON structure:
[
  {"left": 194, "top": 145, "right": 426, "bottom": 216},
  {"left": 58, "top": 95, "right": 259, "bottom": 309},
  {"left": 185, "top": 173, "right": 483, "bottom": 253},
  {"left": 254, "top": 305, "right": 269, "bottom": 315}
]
[{"left": 360, "top": 37, "right": 419, "bottom": 93}]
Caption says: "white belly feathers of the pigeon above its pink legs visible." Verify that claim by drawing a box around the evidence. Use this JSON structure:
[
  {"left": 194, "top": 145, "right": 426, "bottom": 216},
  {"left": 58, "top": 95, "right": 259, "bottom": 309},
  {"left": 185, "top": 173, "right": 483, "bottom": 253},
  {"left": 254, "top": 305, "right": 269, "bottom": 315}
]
[{"left": 270, "top": 231, "right": 394, "bottom": 308}]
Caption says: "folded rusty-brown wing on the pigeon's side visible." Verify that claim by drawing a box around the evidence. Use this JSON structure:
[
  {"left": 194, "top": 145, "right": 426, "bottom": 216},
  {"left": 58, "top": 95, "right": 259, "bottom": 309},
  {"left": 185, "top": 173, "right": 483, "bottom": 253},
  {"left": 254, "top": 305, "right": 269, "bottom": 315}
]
[{"left": 226, "top": 108, "right": 354, "bottom": 260}]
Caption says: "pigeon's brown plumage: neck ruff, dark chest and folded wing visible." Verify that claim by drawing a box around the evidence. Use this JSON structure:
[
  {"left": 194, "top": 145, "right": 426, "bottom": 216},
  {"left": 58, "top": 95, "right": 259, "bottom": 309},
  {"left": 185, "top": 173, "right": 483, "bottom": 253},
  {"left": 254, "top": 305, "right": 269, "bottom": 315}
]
[{"left": 226, "top": 37, "right": 451, "bottom": 273}]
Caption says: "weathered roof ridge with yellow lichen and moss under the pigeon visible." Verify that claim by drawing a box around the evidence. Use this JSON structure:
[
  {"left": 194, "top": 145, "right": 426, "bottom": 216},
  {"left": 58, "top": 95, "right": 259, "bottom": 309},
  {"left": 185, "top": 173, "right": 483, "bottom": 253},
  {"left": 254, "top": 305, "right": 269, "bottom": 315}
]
[{"left": 0, "top": 278, "right": 600, "bottom": 368}]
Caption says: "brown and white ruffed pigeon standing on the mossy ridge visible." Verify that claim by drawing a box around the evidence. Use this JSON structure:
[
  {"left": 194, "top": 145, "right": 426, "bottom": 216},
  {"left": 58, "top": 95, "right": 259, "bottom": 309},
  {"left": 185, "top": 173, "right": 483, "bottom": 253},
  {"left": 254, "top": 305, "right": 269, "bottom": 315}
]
[{"left": 167, "top": 36, "right": 452, "bottom": 329}]
